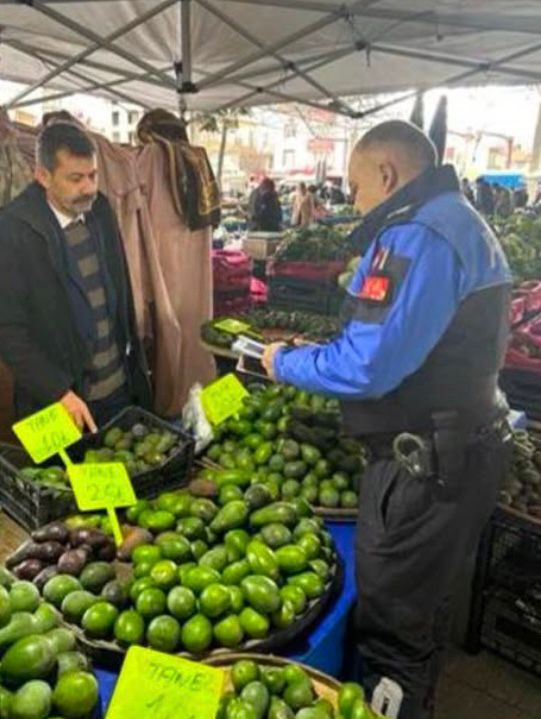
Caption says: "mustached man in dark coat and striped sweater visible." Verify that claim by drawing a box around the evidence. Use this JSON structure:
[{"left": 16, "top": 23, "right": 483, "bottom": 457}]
[{"left": 0, "top": 122, "right": 151, "bottom": 431}]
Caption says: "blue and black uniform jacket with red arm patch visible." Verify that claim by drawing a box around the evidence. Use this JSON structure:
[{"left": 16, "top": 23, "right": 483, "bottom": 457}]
[{"left": 274, "top": 166, "right": 511, "bottom": 436}]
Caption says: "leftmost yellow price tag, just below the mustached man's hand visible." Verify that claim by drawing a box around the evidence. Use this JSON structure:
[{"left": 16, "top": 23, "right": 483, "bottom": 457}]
[{"left": 13, "top": 402, "right": 82, "bottom": 464}]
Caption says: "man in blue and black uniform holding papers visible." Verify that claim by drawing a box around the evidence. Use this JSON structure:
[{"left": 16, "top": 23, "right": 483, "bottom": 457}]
[{"left": 263, "top": 121, "right": 511, "bottom": 719}]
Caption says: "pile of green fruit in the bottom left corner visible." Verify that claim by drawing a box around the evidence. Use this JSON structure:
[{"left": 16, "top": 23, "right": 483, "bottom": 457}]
[{"left": 0, "top": 572, "right": 99, "bottom": 719}]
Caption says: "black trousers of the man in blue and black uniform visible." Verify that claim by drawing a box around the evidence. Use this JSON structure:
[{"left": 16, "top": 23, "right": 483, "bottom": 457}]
[{"left": 355, "top": 433, "right": 510, "bottom": 719}]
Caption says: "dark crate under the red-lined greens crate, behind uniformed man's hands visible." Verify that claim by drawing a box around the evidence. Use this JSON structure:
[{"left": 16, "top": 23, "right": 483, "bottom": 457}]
[{"left": 268, "top": 277, "right": 342, "bottom": 315}]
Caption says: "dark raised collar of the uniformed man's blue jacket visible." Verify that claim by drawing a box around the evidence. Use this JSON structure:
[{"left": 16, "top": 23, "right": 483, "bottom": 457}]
[{"left": 355, "top": 165, "right": 460, "bottom": 246}]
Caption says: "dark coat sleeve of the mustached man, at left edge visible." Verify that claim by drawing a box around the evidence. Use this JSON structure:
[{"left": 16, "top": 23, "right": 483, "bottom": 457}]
[{"left": 0, "top": 236, "right": 73, "bottom": 406}]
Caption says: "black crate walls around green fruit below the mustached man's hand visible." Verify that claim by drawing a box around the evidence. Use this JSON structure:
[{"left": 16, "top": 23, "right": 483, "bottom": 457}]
[{"left": 69, "top": 407, "right": 195, "bottom": 499}]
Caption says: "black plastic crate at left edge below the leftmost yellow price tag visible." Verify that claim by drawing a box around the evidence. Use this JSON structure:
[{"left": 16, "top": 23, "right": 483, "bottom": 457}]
[{"left": 0, "top": 444, "right": 77, "bottom": 531}]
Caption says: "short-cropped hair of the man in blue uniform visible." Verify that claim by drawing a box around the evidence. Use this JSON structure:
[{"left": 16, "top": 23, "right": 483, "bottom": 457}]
[{"left": 355, "top": 120, "right": 438, "bottom": 169}]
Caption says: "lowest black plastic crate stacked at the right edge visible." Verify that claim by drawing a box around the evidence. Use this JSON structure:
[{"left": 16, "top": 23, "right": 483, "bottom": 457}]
[{"left": 481, "top": 590, "right": 541, "bottom": 676}]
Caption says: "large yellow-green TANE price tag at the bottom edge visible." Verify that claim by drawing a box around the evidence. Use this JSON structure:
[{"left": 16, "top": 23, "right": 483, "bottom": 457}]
[{"left": 106, "top": 647, "right": 224, "bottom": 719}]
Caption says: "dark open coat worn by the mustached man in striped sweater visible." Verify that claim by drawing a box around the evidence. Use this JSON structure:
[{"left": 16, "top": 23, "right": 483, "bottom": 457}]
[{"left": 0, "top": 183, "right": 151, "bottom": 417}]
